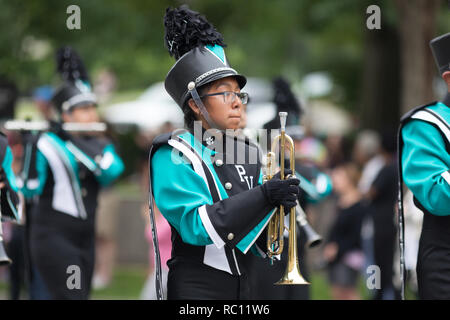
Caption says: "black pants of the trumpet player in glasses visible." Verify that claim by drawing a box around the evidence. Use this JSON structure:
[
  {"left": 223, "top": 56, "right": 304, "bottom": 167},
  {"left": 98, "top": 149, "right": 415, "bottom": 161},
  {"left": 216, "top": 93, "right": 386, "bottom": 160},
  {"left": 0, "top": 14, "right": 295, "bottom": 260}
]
[{"left": 167, "top": 258, "right": 250, "bottom": 300}]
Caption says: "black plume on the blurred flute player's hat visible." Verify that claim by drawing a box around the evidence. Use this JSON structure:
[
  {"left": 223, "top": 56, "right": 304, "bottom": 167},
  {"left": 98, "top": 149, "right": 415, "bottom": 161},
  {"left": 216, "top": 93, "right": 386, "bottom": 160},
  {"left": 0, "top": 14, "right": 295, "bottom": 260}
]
[{"left": 56, "top": 46, "right": 89, "bottom": 83}]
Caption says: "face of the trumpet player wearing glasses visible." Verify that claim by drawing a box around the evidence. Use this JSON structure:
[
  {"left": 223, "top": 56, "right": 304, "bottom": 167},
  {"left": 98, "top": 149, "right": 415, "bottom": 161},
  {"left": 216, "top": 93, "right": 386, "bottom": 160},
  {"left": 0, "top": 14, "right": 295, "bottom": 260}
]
[{"left": 189, "top": 77, "right": 243, "bottom": 130}]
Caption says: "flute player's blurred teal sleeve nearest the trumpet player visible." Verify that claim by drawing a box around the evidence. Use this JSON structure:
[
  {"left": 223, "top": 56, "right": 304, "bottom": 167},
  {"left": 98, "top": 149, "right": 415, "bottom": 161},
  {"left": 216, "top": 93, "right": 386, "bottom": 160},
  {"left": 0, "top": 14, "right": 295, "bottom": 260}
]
[{"left": 96, "top": 144, "right": 125, "bottom": 186}]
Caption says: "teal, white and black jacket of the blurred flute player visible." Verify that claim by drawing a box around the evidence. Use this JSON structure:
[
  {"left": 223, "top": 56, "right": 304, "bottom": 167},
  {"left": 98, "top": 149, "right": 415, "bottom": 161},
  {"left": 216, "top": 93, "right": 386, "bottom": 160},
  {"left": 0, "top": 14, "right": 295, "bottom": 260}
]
[{"left": 21, "top": 132, "right": 124, "bottom": 221}]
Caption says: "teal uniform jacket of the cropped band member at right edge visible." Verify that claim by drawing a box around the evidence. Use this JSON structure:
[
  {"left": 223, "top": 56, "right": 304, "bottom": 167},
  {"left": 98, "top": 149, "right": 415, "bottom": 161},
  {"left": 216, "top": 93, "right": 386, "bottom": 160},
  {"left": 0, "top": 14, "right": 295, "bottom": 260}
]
[{"left": 400, "top": 94, "right": 450, "bottom": 216}]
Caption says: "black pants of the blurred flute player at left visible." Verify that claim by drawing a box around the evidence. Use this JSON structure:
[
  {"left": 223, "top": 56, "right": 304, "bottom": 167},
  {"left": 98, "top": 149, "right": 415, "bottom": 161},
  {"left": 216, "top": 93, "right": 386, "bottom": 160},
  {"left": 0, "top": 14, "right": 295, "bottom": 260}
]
[{"left": 30, "top": 212, "right": 95, "bottom": 300}]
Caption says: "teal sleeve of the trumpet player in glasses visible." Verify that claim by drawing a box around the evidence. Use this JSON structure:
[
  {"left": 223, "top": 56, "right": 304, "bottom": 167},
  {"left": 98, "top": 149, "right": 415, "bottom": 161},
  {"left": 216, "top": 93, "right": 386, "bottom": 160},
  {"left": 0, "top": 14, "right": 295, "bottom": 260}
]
[{"left": 151, "top": 146, "right": 213, "bottom": 246}]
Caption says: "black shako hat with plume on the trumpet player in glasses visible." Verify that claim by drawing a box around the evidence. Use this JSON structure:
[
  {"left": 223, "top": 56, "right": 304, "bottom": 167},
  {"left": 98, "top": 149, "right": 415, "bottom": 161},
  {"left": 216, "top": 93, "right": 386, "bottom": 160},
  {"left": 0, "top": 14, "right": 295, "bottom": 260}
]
[{"left": 164, "top": 5, "right": 247, "bottom": 109}]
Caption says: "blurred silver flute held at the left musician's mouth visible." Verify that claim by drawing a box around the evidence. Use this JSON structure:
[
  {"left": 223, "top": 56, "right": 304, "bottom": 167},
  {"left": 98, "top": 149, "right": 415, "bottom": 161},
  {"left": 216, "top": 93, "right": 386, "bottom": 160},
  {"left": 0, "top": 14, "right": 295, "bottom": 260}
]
[{"left": 5, "top": 120, "right": 107, "bottom": 132}]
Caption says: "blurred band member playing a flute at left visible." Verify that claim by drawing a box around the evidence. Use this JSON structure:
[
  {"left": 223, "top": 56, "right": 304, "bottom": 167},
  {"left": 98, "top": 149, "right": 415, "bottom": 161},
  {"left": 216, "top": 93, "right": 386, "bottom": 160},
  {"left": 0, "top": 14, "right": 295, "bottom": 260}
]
[{"left": 22, "top": 47, "right": 124, "bottom": 299}]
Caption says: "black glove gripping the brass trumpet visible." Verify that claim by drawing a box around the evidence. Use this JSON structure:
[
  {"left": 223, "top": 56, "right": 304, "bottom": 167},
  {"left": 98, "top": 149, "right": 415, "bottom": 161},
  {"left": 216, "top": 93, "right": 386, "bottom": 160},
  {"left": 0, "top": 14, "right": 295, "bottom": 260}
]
[{"left": 262, "top": 170, "right": 300, "bottom": 212}]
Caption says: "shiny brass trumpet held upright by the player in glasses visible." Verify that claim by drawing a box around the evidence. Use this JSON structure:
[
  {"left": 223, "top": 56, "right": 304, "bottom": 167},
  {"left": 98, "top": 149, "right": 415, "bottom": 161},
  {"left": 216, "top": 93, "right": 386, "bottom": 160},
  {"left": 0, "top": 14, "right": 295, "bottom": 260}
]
[{"left": 264, "top": 112, "right": 309, "bottom": 285}]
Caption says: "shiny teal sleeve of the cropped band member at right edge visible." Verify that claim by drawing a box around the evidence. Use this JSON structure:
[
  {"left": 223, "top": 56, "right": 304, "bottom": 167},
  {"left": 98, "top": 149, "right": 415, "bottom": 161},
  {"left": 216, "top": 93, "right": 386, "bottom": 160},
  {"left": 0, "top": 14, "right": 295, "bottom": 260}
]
[{"left": 402, "top": 120, "right": 450, "bottom": 216}]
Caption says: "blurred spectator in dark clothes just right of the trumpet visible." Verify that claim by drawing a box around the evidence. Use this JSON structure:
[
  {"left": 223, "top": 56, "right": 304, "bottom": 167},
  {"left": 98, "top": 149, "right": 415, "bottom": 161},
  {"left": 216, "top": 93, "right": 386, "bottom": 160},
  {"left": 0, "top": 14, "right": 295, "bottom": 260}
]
[{"left": 323, "top": 163, "right": 365, "bottom": 300}]
